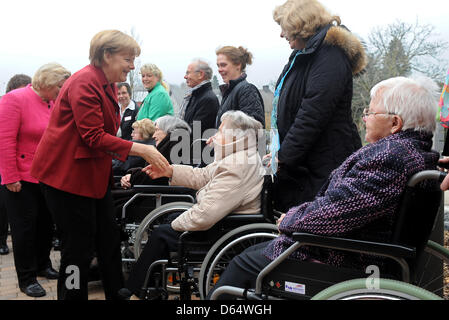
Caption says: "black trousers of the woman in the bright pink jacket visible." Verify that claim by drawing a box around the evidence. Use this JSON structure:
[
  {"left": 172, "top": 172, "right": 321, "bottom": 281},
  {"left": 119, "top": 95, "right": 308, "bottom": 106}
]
[{"left": 3, "top": 181, "right": 53, "bottom": 287}]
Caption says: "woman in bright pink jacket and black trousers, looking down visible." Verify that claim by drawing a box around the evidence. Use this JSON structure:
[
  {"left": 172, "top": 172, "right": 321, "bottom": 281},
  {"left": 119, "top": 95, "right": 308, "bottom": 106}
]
[{"left": 0, "top": 63, "right": 70, "bottom": 297}]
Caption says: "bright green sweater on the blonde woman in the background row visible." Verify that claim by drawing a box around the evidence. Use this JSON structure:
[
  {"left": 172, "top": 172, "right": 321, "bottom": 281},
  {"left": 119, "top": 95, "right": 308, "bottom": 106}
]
[{"left": 137, "top": 82, "right": 174, "bottom": 121}]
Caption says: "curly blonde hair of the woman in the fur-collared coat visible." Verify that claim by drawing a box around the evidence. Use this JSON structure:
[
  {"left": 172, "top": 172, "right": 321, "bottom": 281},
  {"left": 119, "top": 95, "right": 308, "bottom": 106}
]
[{"left": 273, "top": 0, "right": 341, "bottom": 39}]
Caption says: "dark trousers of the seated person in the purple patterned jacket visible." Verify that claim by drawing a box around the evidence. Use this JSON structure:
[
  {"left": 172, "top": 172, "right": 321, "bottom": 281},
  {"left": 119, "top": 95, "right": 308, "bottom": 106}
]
[{"left": 206, "top": 242, "right": 271, "bottom": 300}]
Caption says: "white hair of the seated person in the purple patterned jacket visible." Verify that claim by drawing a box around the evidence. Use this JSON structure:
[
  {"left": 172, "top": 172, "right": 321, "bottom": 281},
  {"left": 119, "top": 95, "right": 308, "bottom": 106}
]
[{"left": 371, "top": 76, "right": 439, "bottom": 133}]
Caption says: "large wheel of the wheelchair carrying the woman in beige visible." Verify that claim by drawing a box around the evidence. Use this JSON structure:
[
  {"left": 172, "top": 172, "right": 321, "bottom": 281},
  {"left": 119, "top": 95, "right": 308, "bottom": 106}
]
[{"left": 198, "top": 223, "right": 279, "bottom": 300}]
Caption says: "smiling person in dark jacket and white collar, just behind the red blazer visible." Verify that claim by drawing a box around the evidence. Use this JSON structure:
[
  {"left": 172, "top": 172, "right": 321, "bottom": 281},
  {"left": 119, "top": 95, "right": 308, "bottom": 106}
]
[{"left": 117, "top": 82, "right": 139, "bottom": 140}]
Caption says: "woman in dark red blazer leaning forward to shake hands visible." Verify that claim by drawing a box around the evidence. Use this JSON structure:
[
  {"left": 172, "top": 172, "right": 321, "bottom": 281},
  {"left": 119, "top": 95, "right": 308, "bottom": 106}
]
[{"left": 31, "top": 30, "right": 168, "bottom": 300}]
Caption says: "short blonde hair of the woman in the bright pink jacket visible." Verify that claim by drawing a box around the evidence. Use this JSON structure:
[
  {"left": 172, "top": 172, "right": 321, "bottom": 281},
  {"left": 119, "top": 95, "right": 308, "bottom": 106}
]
[{"left": 31, "top": 62, "right": 71, "bottom": 90}]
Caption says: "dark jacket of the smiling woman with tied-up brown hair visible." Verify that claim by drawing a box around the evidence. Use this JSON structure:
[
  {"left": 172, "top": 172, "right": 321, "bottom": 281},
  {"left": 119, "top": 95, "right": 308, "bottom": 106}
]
[{"left": 215, "top": 74, "right": 265, "bottom": 128}]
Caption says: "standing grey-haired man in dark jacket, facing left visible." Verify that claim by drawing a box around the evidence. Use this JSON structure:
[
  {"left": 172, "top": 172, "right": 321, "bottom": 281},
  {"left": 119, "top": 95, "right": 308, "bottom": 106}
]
[{"left": 179, "top": 60, "right": 220, "bottom": 166}]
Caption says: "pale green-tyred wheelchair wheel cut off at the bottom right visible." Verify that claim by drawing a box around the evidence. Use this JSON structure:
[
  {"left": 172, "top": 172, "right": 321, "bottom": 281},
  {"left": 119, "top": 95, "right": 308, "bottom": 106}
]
[{"left": 312, "top": 279, "right": 443, "bottom": 300}]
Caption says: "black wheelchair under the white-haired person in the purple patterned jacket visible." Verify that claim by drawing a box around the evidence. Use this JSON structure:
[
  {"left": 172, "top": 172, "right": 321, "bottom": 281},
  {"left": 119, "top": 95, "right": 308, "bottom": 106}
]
[{"left": 211, "top": 170, "right": 449, "bottom": 300}]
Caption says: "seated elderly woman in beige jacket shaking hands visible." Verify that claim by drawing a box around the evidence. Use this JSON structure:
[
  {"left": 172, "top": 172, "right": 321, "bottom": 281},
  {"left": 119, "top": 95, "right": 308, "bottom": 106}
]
[{"left": 119, "top": 111, "right": 264, "bottom": 299}]
